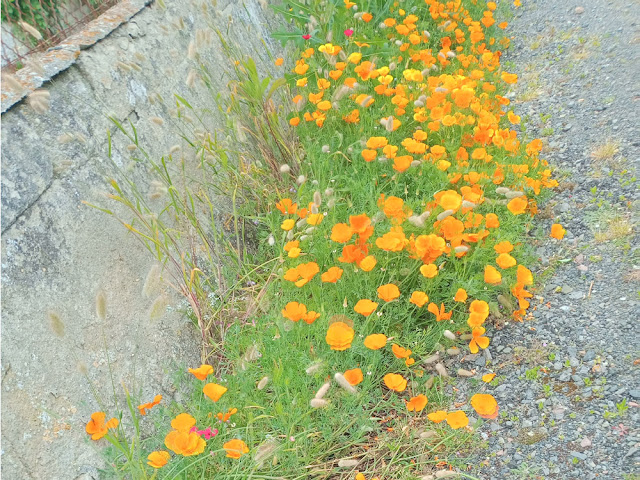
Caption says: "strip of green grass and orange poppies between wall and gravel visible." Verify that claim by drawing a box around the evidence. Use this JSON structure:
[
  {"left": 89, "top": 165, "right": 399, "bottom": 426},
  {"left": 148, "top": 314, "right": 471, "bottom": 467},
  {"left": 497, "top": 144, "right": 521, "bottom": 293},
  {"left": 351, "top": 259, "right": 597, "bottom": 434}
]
[{"left": 82, "top": 1, "right": 557, "bottom": 479}]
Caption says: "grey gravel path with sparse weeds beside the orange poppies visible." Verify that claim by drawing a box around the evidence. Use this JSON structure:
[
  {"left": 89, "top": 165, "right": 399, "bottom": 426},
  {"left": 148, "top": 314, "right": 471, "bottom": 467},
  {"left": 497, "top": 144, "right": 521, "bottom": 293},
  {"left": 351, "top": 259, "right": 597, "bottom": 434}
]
[{"left": 470, "top": 0, "right": 640, "bottom": 480}]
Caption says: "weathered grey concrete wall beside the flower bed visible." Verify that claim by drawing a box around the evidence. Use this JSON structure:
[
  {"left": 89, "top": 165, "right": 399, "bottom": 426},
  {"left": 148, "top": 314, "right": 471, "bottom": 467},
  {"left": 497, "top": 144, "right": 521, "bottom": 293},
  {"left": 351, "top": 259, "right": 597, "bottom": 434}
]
[{"left": 1, "top": 0, "right": 278, "bottom": 480}]
